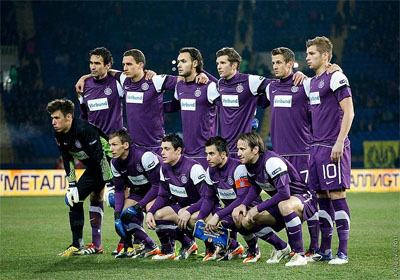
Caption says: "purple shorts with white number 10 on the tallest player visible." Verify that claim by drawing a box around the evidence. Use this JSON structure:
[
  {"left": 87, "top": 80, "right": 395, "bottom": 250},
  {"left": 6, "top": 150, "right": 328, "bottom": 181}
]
[{"left": 308, "top": 144, "right": 351, "bottom": 191}]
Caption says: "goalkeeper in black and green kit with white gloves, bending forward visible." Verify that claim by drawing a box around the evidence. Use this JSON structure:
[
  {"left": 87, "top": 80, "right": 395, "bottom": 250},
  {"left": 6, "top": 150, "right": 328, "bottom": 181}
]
[{"left": 47, "top": 99, "right": 112, "bottom": 256}]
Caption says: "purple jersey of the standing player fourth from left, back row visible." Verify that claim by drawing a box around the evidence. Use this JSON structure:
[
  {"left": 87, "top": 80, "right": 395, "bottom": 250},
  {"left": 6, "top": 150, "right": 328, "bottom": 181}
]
[{"left": 218, "top": 72, "right": 269, "bottom": 152}]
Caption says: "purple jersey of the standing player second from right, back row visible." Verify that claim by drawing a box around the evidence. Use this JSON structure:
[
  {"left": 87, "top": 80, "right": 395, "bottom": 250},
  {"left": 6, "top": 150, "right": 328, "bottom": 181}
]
[{"left": 266, "top": 74, "right": 311, "bottom": 156}]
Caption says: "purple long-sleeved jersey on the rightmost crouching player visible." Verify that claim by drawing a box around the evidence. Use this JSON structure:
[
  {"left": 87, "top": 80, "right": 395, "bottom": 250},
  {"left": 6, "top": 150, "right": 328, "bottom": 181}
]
[{"left": 243, "top": 150, "right": 309, "bottom": 212}]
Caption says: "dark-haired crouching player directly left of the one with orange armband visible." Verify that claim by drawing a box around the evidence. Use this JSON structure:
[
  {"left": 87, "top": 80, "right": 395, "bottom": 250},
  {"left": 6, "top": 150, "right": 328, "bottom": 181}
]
[{"left": 146, "top": 134, "right": 205, "bottom": 260}]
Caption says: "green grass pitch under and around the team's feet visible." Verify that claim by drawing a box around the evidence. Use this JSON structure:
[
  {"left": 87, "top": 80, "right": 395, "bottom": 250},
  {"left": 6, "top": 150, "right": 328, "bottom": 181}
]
[{"left": 0, "top": 193, "right": 400, "bottom": 280}]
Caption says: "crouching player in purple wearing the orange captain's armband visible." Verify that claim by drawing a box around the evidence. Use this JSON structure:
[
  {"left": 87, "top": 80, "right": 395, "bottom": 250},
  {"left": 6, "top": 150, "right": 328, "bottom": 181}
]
[{"left": 197, "top": 136, "right": 290, "bottom": 263}]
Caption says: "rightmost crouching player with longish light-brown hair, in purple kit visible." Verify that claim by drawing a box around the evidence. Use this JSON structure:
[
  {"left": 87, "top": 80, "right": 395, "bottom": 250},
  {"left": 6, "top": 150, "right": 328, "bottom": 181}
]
[{"left": 236, "top": 133, "right": 316, "bottom": 266}]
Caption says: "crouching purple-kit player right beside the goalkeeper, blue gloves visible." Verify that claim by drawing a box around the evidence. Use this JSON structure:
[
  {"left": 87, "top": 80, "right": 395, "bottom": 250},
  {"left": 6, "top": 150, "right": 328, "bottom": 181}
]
[{"left": 106, "top": 130, "right": 160, "bottom": 258}]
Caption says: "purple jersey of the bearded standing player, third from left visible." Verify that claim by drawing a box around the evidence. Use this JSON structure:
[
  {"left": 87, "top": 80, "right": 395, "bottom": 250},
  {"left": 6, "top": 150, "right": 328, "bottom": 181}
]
[{"left": 174, "top": 81, "right": 219, "bottom": 158}]
